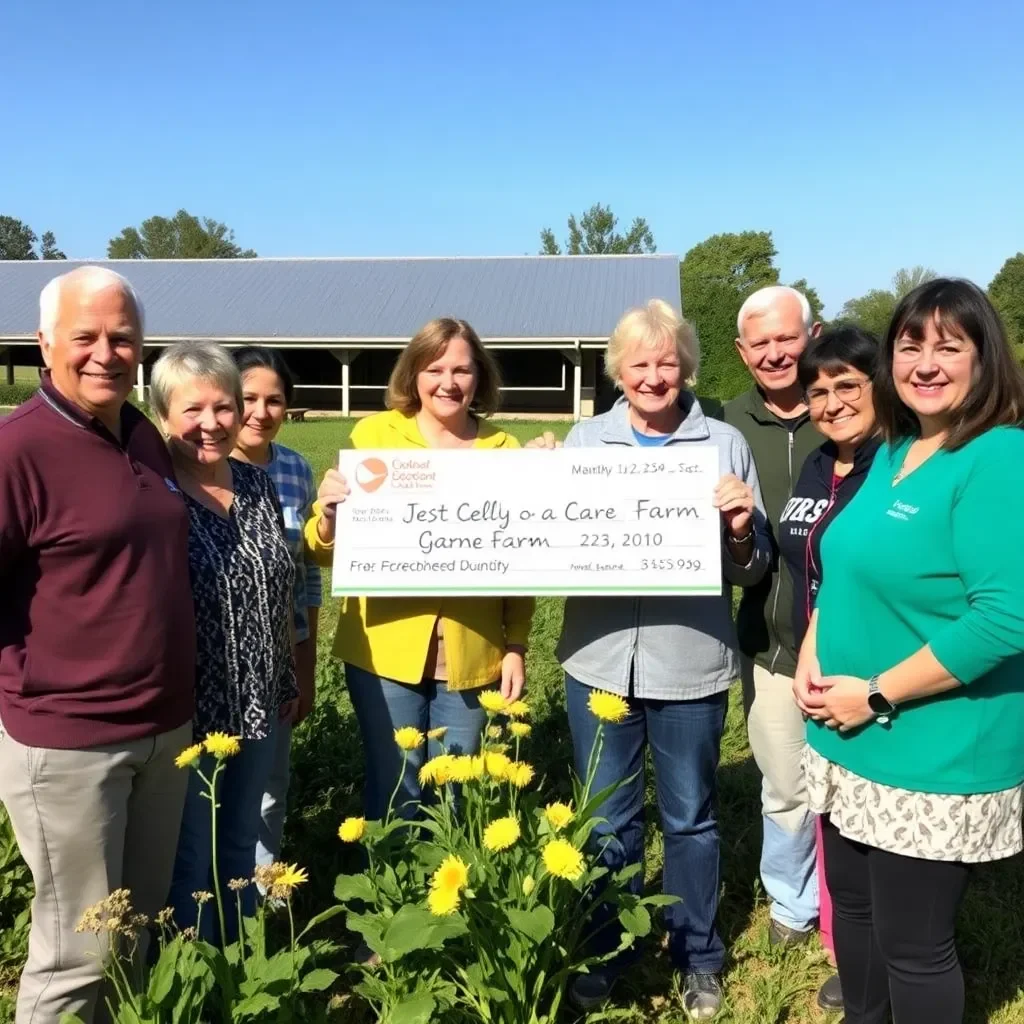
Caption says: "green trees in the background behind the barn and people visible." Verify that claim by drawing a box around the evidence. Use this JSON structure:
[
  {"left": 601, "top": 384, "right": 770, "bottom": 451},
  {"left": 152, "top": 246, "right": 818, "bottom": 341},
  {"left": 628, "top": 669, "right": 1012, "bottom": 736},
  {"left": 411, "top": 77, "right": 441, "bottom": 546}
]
[{"left": 0, "top": 203, "right": 1024, "bottom": 399}]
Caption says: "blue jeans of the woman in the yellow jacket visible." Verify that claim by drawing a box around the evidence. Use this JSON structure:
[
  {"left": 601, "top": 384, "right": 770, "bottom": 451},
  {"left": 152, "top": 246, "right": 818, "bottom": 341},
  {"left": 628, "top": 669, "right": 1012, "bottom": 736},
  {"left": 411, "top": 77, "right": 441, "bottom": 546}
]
[{"left": 345, "top": 662, "right": 487, "bottom": 821}]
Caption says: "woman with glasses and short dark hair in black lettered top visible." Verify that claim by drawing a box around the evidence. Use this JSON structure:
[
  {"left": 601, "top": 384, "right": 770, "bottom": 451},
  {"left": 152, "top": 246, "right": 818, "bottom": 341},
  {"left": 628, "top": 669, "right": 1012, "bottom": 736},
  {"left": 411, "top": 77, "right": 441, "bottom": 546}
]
[{"left": 778, "top": 327, "right": 879, "bottom": 1010}]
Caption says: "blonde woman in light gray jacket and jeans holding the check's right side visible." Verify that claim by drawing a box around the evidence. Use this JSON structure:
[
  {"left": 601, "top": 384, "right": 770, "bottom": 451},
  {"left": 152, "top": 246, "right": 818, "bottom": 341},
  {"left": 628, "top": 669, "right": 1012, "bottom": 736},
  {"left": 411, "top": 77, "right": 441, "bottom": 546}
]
[{"left": 531, "top": 300, "right": 772, "bottom": 1020}]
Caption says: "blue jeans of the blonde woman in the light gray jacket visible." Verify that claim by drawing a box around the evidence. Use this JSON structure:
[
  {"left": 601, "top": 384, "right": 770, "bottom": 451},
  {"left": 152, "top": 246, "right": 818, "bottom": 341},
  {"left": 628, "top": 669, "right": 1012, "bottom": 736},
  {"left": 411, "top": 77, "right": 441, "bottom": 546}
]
[{"left": 565, "top": 675, "right": 729, "bottom": 974}]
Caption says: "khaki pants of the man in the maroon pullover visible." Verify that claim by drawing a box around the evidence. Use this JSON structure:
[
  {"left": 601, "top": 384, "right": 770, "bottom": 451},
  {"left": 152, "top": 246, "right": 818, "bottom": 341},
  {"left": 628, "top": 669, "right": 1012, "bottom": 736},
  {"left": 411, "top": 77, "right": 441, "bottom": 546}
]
[{"left": 0, "top": 723, "right": 191, "bottom": 1024}]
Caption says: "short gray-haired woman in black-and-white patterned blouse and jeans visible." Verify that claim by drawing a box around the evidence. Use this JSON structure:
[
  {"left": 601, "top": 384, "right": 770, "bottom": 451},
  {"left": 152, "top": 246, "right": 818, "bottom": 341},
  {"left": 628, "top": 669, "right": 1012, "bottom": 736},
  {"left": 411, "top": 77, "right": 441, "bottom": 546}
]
[{"left": 151, "top": 341, "right": 298, "bottom": 942}]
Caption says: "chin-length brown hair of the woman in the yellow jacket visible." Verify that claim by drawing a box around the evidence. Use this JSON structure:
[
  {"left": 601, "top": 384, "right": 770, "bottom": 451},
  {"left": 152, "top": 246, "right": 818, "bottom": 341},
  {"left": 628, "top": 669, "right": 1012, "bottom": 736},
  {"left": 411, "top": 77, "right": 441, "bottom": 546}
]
[{"left": 384, "top": 316, "right": 502, "bottom": 416}]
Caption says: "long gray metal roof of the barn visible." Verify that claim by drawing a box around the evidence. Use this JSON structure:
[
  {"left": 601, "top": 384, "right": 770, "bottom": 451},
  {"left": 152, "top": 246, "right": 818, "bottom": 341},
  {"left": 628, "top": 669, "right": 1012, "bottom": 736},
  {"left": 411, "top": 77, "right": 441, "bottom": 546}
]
[{"left": 0, "top": 255, "right": 679, "bottom": 344}]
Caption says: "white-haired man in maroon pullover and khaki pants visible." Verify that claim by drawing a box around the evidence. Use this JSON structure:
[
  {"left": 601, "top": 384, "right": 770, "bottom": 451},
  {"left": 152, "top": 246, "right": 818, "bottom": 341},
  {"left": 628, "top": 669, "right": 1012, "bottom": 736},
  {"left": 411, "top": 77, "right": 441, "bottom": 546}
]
[{"left": 0, "top": 267, "right": 196, "bottom": 1024}]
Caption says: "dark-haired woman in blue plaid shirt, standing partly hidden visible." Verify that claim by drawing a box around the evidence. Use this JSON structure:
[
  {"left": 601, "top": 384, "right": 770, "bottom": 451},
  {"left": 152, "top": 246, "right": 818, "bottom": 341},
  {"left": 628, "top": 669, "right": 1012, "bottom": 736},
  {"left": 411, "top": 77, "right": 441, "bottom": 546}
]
[{"left": 231, "top": 346, "right": 322, "bottom": 864}]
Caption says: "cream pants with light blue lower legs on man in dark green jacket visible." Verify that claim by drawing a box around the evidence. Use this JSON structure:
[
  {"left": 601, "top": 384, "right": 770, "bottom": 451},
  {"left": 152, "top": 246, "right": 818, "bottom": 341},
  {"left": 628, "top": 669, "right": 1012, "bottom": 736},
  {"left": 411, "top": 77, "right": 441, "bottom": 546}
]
[{"left": 741, "top": 656, "right": 819, "bottom": 932}]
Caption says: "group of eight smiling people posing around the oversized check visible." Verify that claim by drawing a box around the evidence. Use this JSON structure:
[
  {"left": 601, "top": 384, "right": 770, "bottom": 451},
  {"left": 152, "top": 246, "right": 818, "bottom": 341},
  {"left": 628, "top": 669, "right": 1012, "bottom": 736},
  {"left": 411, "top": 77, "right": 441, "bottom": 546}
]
[{"left": 0, "top": 267, "right": 1024, "bottom": 1024}]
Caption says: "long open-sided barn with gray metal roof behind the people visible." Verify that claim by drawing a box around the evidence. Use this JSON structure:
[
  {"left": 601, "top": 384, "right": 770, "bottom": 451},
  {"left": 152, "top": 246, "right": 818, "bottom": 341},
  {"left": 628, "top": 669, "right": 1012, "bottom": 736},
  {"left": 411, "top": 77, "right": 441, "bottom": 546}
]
[{"left": 6, "top": 255, "right": 680, "bottom": 419}]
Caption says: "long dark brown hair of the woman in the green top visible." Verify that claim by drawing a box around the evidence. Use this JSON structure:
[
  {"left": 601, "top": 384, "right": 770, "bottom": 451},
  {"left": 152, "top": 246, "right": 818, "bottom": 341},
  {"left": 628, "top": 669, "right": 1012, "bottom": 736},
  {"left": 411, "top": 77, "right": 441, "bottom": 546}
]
[{"left": 874, "top": 278, "right": 1024, "bottom": 452}]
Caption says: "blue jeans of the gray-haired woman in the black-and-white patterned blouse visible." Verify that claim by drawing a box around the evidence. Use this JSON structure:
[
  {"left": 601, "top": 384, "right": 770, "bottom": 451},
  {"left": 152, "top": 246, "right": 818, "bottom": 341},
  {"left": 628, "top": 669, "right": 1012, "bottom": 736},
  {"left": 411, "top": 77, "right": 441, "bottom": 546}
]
[{"left": 170, "top": 723, "right": 278, "bottom": 942}]
